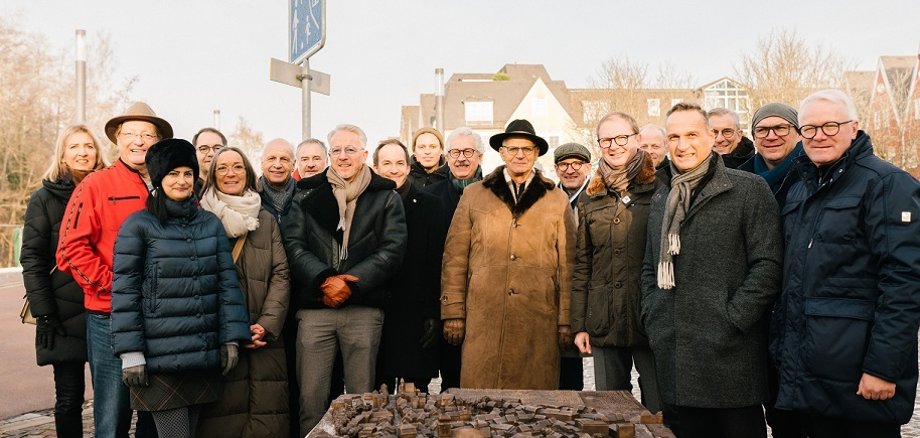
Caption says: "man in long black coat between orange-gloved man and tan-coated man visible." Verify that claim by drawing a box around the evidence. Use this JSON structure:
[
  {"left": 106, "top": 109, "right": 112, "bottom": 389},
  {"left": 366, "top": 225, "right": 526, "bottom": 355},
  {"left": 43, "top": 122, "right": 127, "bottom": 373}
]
[{"left": 374, "top": 139, "right": 447, "bottom": 392}]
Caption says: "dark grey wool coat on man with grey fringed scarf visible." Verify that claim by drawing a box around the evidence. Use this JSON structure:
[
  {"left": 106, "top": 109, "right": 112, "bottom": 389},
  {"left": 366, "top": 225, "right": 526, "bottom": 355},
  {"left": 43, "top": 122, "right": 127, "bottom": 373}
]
[{"left": 641, "top": 153, "right": 782, "bottom": 408}]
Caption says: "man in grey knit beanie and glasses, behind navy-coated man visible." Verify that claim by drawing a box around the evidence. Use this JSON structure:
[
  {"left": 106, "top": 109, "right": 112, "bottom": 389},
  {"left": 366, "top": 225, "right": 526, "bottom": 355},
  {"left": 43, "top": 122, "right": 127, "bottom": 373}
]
[{"left": 738, "top": 102, "right": 802, "bottom": 207}]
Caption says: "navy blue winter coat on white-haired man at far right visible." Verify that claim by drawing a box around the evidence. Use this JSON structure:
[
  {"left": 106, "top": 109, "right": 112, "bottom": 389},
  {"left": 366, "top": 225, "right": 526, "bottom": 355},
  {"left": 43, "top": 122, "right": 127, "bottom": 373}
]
[{"left": 770, "top": 131, "right": 920, "bottom": 424}]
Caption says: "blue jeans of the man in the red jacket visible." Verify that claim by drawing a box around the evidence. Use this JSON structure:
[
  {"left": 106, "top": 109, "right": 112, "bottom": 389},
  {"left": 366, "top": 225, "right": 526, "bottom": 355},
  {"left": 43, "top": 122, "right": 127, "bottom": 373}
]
[{"left": 86, "top": 313, "right": 131, "bottom": 438}]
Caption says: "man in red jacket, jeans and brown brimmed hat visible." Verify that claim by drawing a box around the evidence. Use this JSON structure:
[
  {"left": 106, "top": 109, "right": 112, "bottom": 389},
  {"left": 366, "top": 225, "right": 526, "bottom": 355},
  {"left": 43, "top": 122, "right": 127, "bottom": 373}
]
[{"left": 57, "top": 102, "right": 173, "bottom": 437}]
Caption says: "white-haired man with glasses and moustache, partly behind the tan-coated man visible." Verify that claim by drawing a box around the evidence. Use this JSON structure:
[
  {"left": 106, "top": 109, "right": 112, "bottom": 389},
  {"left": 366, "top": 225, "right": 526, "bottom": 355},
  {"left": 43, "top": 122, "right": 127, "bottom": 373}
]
[{"left": 425, "top": 127, "right": 483, "bottom": 391}]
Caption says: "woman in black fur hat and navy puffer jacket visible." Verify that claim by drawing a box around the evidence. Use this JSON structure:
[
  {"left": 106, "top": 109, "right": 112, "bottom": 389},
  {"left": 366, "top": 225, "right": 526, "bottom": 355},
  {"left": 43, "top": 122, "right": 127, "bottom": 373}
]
[{"left": 112, "top": 139, "right": 250, "bottom": 437}]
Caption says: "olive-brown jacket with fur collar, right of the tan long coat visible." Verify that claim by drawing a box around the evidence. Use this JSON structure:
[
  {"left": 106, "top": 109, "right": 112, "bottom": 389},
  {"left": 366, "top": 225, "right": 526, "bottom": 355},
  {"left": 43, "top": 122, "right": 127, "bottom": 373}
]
[{"left": 572, "top": 157, "right": 661, "bottom": 347}]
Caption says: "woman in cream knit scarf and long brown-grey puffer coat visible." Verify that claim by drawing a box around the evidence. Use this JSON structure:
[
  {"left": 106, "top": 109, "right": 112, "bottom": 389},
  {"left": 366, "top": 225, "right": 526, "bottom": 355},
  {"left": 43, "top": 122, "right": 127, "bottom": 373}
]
[{"left": 198, "top": 147, "right": 290, "bottom": 437}]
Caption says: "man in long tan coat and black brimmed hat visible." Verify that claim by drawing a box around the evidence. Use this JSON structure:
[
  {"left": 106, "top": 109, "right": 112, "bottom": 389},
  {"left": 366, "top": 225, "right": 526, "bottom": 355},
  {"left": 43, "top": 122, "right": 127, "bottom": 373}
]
[{"left": 441, "top": 120, "right": 575, "bottom": 389}]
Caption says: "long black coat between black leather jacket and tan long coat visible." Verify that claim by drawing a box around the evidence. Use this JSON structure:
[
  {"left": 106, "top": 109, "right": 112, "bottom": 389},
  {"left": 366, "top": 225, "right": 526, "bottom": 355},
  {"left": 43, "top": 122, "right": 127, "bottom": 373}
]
[{"left": 380, "top": 186, "right": 447, "bottom": 379}]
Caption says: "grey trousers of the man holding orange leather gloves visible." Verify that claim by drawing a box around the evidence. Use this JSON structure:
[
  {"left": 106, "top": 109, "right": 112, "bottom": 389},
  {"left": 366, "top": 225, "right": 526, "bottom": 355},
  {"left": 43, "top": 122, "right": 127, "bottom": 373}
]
[{"left": 296, "top": 306, "right": 383, "bottom": 436}]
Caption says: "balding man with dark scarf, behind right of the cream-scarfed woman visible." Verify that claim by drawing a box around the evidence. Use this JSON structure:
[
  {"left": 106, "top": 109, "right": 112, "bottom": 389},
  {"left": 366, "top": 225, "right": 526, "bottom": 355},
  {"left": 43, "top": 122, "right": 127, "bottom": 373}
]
[{"left": 259, "top": 138, "right": 296, "bottom": 223}]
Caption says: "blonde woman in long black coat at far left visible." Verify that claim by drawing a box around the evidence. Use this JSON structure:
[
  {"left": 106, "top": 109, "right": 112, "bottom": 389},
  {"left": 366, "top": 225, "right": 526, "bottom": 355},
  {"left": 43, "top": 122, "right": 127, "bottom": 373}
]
[{"left": 19, "top": 125, "right": 105, "bottom": 438}]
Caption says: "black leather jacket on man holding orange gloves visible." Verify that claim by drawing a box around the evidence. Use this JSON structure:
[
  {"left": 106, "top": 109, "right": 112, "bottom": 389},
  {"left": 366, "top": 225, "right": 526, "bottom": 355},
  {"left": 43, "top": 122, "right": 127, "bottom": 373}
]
[{"left": 281, "top": 168, "right": 407, "bottom": 309}]
